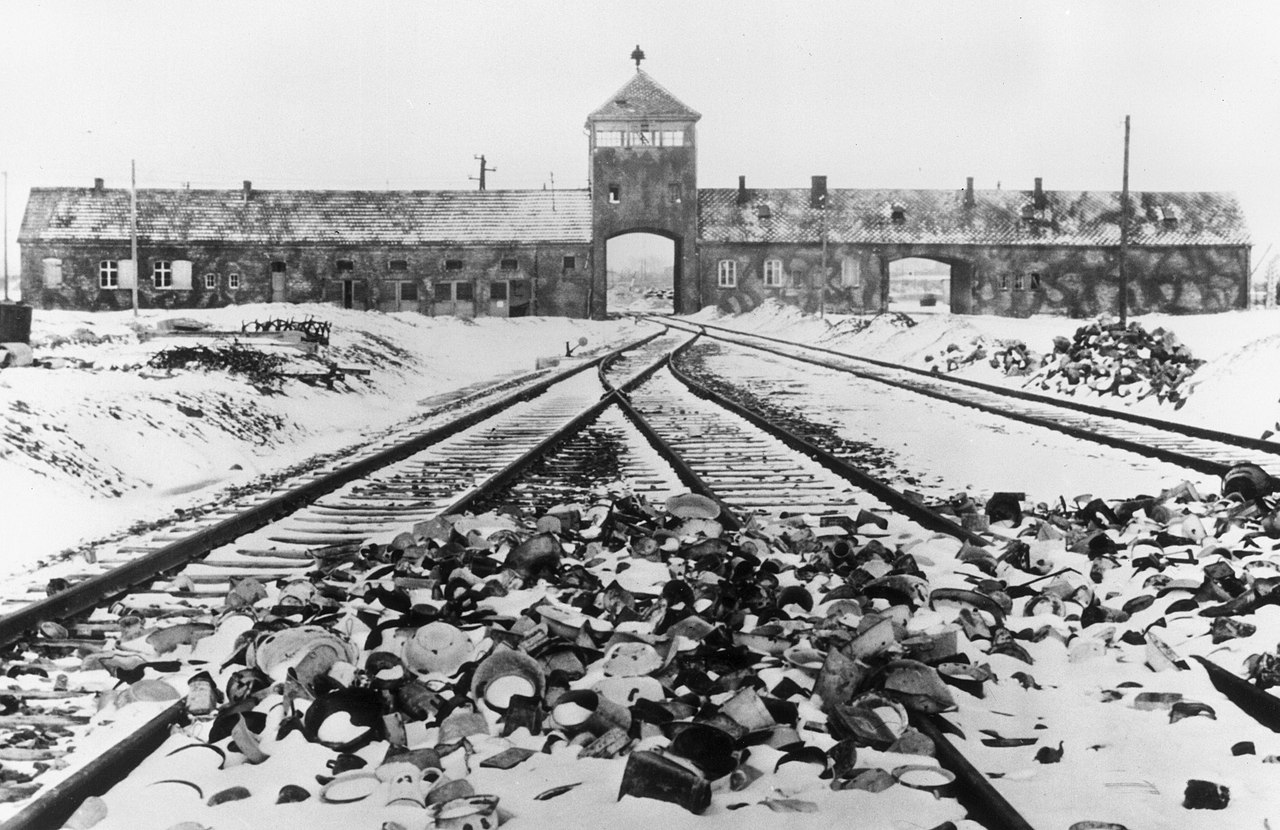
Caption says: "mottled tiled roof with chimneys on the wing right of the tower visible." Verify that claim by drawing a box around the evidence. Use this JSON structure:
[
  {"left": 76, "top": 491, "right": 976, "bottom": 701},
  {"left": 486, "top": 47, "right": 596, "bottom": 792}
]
[{"left": 698, "top": 188, "right": 1249, "bottom": 246}]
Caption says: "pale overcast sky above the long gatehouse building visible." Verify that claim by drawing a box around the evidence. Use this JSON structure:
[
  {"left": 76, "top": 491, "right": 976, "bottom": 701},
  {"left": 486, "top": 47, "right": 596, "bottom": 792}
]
[{"left": 0, "top": 0, "right": 1280, "bottom": 288}]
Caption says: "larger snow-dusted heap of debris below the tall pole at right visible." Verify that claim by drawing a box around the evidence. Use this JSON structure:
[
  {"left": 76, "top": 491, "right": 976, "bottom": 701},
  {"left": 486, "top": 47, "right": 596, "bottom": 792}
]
[{"left": 1028, "top": 321, "right": 1204, "bottom": 407}]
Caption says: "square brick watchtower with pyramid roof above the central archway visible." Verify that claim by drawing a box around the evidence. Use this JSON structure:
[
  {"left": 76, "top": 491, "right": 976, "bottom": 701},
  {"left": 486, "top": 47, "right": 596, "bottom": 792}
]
[{"left": 586, "top": 46, "right": 701, "bottom": 318}]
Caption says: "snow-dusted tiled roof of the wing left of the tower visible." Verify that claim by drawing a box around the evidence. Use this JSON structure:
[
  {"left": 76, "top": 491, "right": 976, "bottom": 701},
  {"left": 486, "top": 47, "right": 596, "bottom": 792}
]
[{"left": 18, "top": 187, "right": 591, "bottom": 245}]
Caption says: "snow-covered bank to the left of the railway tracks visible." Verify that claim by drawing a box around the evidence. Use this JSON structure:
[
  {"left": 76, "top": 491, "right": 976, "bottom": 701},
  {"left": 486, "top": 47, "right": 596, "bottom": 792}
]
[{"left": 0, "top": 305, "right": 648, "bottom": 573}]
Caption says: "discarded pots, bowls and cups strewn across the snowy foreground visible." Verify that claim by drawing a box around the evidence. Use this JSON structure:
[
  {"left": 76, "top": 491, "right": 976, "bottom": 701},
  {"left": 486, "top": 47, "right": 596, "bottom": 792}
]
[{"left": 0, "top": 470, "right": 1280, "bottom": 830}]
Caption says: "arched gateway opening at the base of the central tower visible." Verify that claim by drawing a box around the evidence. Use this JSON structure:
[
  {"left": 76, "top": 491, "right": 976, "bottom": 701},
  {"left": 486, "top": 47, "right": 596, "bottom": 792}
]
[{"left": 604, "top": 231, "right": 680, "bottom": 314}]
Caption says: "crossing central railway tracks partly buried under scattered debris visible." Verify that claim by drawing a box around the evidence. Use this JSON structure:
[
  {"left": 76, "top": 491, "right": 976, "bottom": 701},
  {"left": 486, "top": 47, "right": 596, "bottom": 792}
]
[{"left": 0, "top": 316, "right": 1274, "bottom": 830}]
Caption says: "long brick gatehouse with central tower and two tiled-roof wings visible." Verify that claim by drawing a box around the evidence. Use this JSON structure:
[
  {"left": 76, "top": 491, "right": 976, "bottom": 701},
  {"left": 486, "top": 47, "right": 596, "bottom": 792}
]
[{"left": 18, "top": 52, "right": 1249, "bottom": 318}]
